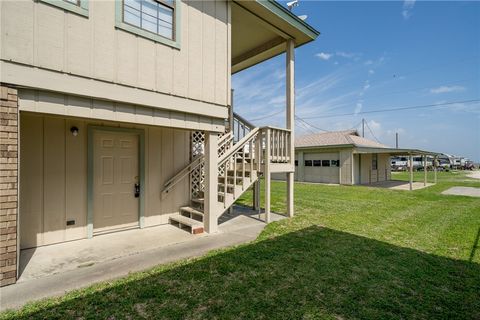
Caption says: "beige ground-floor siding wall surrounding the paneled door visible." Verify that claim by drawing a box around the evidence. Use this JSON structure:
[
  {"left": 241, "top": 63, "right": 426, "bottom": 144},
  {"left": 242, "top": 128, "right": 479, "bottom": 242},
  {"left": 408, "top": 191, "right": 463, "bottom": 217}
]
[{"left": 20, "top": 113, "right": 190, "bottom": 248}]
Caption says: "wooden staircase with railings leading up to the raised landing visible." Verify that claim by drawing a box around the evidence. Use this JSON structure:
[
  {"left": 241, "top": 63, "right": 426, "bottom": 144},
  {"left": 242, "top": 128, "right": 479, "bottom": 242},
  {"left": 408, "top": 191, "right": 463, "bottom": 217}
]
[{"left": 162, "top": 120, "right": 294, "bottom": 234}]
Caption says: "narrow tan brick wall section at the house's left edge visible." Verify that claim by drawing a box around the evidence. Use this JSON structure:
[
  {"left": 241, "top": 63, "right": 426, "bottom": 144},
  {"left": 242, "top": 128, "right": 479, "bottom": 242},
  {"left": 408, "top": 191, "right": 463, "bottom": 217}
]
[{"left": 0, "top": 84, "right": 19, "bottom": 287}]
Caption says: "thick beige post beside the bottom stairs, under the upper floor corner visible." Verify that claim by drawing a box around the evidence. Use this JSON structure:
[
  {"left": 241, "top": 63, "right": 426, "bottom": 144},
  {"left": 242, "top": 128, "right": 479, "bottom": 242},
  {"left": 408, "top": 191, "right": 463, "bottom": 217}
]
[{"left": 203, "top": 132, "right": 218, "bottom": 233}]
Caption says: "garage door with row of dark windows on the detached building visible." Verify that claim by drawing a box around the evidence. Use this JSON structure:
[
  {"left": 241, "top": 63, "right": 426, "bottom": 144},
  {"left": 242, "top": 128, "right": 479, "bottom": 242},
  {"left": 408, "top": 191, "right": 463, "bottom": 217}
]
[{"left": 304, "top": 152, "right": 340, "bottom": 183}]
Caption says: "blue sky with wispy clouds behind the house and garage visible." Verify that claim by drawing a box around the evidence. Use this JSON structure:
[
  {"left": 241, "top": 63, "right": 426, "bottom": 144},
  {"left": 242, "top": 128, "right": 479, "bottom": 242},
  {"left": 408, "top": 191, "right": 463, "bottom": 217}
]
[{"left": 233, "top": 0, "right": 480, "bottom": 161}]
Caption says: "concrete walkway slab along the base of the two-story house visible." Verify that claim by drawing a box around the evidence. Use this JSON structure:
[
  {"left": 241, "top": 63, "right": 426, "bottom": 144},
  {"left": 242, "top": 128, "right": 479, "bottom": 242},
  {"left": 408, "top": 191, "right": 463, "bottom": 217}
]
[{"left": 0, "top": 207, "right": 284, "bottom": 311}]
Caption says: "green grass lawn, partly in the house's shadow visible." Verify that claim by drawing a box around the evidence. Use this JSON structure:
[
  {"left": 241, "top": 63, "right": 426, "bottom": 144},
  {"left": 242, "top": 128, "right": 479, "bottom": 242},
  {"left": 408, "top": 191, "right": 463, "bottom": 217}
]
[{"left": 0, "top": 172, "right": 480, "bottom": 319}]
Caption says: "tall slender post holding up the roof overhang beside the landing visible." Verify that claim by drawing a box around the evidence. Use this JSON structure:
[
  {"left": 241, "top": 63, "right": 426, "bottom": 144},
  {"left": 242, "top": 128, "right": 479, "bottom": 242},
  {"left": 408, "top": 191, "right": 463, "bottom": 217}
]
[{"left": 286, "top": 39, "right": 295, "bottom": 217}]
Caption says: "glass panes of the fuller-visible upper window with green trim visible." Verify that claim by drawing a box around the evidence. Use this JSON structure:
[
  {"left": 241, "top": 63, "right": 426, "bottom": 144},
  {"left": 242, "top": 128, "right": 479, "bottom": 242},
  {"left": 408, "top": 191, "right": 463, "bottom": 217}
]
[{"left": 123, "top": 0, "right": 175, "bottom": 40}]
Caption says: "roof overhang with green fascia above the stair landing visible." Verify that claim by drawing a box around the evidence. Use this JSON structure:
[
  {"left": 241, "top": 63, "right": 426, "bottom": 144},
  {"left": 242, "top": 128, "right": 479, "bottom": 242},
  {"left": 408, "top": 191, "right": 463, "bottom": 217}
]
[{"left": 232, "top": 0, "right": 320, "bottom": 74}]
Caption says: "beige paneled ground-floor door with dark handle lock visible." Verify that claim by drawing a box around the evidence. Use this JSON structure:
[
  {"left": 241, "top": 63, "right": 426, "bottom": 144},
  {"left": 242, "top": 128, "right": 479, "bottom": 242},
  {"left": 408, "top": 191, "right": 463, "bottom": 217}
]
[{"left": 93, "top": 130, "right": 140, "bottom": 234}]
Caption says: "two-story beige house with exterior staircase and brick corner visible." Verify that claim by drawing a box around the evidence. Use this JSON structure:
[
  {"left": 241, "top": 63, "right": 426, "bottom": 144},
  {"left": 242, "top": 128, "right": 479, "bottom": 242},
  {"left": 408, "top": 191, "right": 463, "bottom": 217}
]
[{"left": 0, "top": 0, "right": 318, "bottom": 285}]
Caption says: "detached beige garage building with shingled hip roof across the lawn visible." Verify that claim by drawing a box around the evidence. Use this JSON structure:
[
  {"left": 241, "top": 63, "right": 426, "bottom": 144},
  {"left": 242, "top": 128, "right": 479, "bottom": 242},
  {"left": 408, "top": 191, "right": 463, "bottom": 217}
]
[{"left": 295, "top": 130, "right": 394, "bottom": 184}]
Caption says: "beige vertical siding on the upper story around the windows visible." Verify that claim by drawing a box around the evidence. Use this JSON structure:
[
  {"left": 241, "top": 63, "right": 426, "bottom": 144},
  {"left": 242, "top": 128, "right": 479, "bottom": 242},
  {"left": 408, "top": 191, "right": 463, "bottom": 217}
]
[{"left": 0, "top": 0, "right": 231, "bottom": 105}]
